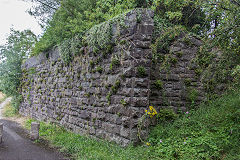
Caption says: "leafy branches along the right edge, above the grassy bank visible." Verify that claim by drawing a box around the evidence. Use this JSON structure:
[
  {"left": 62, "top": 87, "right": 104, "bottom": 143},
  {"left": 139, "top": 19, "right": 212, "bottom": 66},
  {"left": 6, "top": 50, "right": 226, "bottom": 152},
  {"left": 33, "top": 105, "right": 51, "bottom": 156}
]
[{"left": 188, "top": 0, "right": 240, "bottom": 95}]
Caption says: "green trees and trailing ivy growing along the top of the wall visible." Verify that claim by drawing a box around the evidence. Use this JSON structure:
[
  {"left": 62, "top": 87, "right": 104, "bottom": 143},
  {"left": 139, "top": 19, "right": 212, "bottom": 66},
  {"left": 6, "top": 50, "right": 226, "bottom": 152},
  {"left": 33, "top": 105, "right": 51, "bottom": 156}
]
[{"left": 30, "top": 0, "right": 209, "bottom": 58}]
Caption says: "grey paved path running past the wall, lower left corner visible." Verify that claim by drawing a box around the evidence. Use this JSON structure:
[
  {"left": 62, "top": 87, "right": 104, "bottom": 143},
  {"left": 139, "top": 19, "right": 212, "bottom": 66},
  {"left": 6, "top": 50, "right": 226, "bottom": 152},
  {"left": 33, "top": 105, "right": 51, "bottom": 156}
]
[{"left": 0, "top": 99, "right": 68, "bottom": 160}]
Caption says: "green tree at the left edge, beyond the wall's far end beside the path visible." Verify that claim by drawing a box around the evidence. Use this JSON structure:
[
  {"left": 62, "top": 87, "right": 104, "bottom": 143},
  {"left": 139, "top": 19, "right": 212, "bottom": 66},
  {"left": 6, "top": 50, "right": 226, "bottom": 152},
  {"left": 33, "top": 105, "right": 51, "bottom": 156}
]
[{"left": 0, "top": 29, "right": 37, "bottom": 107}]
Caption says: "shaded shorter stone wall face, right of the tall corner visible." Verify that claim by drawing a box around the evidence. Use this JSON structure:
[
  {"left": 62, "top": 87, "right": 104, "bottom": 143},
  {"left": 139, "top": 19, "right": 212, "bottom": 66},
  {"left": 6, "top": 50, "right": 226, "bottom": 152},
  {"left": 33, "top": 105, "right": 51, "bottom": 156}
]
[{"left": 149, "top": 34, "right": 205, "bottom": 112}]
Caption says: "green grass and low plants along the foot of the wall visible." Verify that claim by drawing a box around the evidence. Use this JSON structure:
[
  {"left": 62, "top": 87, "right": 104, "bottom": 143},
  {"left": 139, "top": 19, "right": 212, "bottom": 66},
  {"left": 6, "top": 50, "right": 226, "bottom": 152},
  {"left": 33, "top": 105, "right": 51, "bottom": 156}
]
[{"left": 22, "top": 90, "right": 240, "bottom": 160}]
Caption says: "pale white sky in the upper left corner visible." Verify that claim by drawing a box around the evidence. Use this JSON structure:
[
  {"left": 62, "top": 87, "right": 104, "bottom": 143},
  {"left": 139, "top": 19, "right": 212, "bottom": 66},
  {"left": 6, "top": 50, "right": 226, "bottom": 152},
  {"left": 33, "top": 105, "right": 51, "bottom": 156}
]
[{"left": 0, "top": 0, "right": 42, "bottom": 45}]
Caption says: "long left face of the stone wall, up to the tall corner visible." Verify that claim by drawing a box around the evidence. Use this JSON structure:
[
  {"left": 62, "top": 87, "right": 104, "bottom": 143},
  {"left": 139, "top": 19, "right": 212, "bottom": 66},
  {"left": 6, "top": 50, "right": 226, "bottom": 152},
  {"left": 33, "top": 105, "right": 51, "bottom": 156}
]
[{"left": 20, "top": 10, "right": 154, "bottom": 145}]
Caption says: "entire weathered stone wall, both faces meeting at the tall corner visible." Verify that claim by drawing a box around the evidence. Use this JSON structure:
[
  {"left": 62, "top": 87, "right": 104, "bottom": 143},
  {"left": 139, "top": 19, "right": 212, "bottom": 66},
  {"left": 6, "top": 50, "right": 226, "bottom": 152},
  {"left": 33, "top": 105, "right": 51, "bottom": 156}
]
[{"left": 20, "top": 9, "right": 204, "bottom": 146}]
